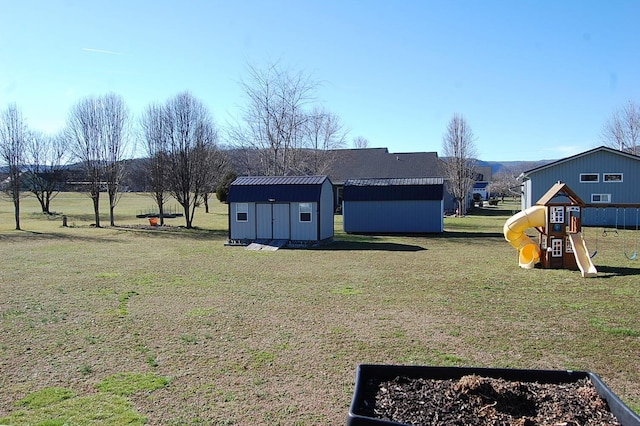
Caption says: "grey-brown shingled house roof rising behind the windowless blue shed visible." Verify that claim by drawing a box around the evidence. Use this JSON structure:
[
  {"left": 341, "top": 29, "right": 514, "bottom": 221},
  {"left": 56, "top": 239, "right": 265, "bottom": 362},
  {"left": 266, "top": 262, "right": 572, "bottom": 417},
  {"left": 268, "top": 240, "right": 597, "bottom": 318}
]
[{"left": 327, "top": 148, "right": 443, "bottom": 184}]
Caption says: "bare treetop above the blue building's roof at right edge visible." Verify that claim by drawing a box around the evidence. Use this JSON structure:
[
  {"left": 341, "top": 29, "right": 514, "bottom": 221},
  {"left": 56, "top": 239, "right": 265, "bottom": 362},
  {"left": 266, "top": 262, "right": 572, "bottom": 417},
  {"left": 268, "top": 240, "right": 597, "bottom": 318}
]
[{"left": 601, "top": 101, "right": 640, "bottom": 155}]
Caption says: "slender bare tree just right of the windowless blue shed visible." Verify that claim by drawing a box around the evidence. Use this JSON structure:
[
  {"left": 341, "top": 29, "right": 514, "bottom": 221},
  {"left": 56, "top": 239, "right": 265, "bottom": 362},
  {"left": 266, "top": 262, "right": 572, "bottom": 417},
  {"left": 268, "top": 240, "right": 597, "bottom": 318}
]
[{"left": 442, "top": 114, "right": 477, "bottom": 215}]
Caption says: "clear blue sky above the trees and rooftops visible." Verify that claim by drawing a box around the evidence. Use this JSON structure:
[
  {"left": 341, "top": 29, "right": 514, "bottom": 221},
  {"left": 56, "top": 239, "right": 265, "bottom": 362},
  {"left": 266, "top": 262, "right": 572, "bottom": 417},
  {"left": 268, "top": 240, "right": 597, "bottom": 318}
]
[{"left": 0, "top": 0, "right": 640, "bottom": 161}]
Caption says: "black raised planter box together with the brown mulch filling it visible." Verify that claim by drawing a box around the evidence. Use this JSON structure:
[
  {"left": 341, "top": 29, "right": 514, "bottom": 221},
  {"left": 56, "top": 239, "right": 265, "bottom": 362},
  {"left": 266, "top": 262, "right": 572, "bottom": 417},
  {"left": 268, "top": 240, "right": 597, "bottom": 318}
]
[{"left": 347, "top": 364, "right": 640, "bottom": 426}]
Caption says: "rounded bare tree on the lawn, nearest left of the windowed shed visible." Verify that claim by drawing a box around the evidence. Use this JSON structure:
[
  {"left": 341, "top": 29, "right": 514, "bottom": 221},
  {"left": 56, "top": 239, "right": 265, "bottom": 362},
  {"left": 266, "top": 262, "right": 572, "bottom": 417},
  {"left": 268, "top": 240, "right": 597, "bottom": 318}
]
[{"left": 164, "top": 92, "right": 218, "bottom": 228}]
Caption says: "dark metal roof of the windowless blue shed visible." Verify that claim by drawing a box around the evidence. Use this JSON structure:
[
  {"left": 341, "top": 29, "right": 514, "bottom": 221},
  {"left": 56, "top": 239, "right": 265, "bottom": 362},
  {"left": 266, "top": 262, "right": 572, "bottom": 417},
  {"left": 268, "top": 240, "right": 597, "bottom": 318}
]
[{"left": 342, "top": 178, "right": 444, "bottom": 202}]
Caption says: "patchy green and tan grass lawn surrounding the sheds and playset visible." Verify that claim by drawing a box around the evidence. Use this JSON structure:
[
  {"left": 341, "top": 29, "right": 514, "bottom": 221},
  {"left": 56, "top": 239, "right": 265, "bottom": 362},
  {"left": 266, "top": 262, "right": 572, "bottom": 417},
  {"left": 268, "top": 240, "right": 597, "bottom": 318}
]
[{"left": 0, "top": 193, "right": 640, "bottom": 425}]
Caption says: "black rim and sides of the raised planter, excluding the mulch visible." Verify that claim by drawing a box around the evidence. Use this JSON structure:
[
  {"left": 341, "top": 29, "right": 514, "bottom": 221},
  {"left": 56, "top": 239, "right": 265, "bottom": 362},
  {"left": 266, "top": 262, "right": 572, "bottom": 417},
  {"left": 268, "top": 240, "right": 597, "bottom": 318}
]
[{"left": 347, "top": 364, "right": 640, "bottom": 426}]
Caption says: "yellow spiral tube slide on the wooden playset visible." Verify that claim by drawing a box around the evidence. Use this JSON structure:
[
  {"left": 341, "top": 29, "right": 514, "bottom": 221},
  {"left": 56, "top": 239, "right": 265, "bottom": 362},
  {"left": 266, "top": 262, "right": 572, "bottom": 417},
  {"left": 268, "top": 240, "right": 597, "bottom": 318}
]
[{"left": 503, "top": 206, "right": 546, "bottom": 269}]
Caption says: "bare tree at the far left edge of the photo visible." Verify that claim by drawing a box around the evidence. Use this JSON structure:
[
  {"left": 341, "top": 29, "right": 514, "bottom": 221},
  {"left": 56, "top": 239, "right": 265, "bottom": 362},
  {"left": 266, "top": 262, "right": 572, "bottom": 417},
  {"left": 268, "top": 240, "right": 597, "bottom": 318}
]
[{"left": 0, "top": 104, "right": 29, "bottom": 231}]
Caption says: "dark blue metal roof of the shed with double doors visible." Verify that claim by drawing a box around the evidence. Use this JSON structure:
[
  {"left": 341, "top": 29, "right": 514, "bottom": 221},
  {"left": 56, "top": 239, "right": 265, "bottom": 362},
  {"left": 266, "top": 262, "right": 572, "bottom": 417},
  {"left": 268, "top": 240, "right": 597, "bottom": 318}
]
[{"left": 227, "top": 176, "right": 331, "bottom": 203}]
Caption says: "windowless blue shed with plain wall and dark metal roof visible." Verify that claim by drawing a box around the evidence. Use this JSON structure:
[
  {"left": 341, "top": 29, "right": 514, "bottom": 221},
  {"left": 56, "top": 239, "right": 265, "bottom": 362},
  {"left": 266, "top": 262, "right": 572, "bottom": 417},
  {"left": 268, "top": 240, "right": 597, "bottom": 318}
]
[{"left": 342, "top": 177, "right": 444, "bottom": 234}]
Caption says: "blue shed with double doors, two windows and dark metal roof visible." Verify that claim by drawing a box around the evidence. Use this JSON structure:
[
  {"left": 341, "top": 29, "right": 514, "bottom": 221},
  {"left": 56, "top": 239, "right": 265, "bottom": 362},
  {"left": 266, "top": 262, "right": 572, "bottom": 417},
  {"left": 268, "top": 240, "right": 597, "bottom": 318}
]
[{"left": 227, "top": 176, "right": 335, "bottom": 243}]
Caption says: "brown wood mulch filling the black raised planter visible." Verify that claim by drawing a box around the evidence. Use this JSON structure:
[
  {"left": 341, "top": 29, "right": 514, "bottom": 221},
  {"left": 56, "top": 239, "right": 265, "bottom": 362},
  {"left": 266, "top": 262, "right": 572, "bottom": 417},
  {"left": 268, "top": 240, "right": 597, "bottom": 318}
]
[{"left": 363, "top": 375, "right": 620, "bottom": 426}]
